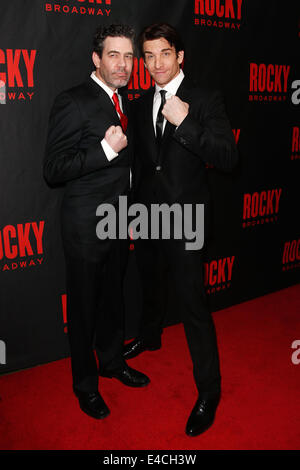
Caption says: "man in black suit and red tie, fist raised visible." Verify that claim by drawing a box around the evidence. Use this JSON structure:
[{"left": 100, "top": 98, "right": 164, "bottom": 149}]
[{"left": 44, "top": 25, "right": 149, "bottom": 419}]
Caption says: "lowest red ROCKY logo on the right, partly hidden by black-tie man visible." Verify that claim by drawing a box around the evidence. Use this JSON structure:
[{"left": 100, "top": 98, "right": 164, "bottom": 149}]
[{"left": 204, "top": 256, "right": 235, "bottom": 294}]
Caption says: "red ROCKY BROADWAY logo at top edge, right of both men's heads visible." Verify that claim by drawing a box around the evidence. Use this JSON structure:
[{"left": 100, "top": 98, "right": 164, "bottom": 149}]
[{"left": 194, "top": 0, "right": 242, "bottom": 31}]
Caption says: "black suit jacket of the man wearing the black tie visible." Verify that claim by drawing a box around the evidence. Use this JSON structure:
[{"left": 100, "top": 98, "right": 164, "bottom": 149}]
[{"left": 133, "top": 78, "right": 238, "bottom": 239}]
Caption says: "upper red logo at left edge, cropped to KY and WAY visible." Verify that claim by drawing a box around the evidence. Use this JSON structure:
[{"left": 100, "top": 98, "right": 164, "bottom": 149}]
[{"left": 0, "top": 49, "right": 37, "bottom": 104}]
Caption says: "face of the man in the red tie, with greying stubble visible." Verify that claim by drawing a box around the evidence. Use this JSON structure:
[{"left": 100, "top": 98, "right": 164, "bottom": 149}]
[{"left": 92, "top": 37, "right": 133, "bottom": 91}]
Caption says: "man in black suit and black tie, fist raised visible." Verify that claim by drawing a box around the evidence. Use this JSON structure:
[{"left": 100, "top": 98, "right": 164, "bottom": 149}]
[{"left": 124, "top": 23, "right": 237, "bottom": 436}]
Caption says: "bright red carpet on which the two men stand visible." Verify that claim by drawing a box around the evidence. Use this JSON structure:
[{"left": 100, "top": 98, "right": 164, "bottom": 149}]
[{"left": 0, "top": 286, "right": 300, "bottom": 450}]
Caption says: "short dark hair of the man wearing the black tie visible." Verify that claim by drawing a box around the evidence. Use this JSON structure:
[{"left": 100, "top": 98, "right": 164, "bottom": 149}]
[{"left": 139, "top": 23, "right": 184, "bottom": 57}]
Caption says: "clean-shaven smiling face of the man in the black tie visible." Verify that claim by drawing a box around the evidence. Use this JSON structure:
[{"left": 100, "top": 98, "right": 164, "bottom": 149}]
[{"left": 143, "top": 38, "right": 184, "bottom": 87}]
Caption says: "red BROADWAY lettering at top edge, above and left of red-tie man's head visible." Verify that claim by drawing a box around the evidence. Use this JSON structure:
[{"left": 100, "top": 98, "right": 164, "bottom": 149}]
[{"left": 45, "top": 0, "right": 112, "bottom": 18}]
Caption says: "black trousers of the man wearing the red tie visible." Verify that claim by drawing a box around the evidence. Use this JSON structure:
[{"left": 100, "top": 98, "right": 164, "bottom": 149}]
[{"left": 65, "top": 240, "right": 128, "bottom": 392}]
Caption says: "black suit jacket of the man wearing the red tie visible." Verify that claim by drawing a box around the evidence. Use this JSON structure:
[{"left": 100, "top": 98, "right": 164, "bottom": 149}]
[{"left": 44, "top": 78, "right": 132, "bottom": 261}]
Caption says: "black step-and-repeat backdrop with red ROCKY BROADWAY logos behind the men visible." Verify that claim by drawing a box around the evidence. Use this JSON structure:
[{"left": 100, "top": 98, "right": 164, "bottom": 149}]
[{"left": 0, "top": 0, "right": 300, "bottom": 373}]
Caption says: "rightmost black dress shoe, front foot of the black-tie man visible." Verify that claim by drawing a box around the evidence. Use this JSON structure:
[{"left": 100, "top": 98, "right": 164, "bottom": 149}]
[{"left": 185, "top": 394, "right": 220, "bottom": 436}]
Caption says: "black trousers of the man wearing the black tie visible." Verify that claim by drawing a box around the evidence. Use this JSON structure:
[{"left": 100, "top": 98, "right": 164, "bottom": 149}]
[{"left": 136, "top": 240, "right": 221, "bottom": 396}]
